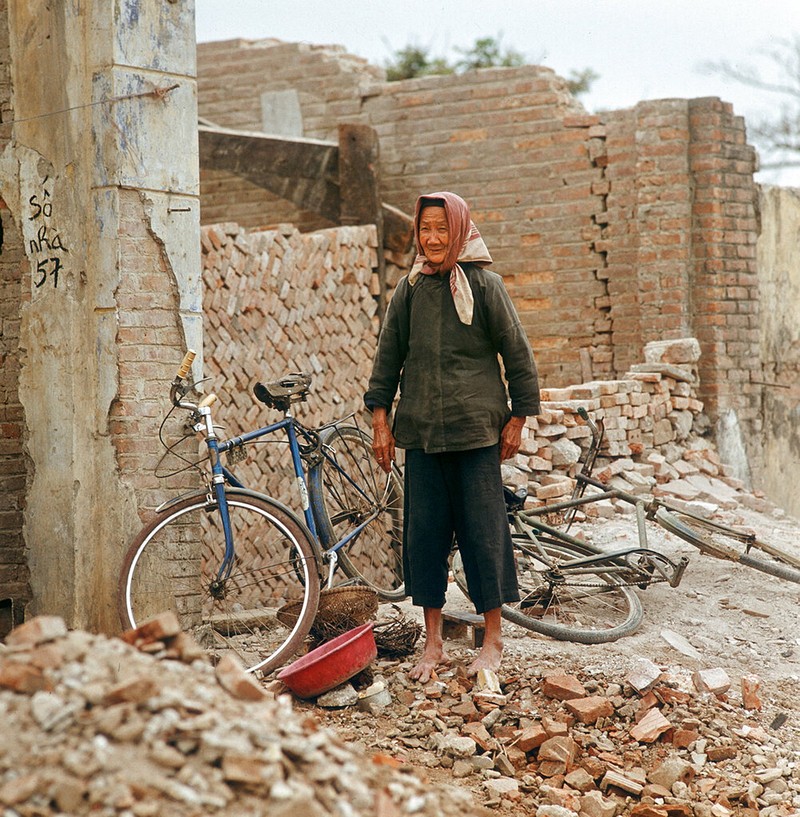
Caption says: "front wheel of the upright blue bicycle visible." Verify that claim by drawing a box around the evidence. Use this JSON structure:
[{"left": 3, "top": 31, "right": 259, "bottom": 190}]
[{"left": 118, "top": 490, "right": 319, "bottom": 673}]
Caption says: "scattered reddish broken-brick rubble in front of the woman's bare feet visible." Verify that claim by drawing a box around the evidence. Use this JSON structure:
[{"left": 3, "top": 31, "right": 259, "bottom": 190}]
[{"left": 317, "top": 657, "right": 800, "bottom": 817}]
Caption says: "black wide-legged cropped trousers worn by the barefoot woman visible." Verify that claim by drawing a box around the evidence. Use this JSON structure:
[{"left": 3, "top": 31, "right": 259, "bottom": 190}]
[{"left": 403, "top": 445, "right": 519, "bottom": 613}]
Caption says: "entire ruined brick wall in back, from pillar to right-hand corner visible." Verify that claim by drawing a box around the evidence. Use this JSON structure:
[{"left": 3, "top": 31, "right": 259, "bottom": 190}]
[{"left": 198, "top": 41, "right": 756, "bottom": 414}]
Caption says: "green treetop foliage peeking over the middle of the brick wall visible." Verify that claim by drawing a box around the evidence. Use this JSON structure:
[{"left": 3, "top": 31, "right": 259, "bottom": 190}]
[{"left": 384, "top": 36, "right": 600, "bottom": 96}]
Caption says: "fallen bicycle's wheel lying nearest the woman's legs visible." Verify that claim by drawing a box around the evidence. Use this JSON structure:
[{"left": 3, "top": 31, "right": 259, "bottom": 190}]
[{"left": 453, "top": 536, "right": 643, "bottom": 644}]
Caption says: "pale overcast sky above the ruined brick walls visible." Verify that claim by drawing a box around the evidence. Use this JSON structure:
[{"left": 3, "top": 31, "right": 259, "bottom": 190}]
[{"left": 195, "top": 0, "right": 800, "bottom": 187}]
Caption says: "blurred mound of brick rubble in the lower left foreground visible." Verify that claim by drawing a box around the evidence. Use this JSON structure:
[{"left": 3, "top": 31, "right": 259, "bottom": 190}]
[{"left": 0, "top": 616, "right": 480, "bottom": 817}]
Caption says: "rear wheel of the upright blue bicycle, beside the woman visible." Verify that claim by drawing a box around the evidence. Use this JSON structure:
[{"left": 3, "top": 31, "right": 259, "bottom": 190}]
[{"left": 308, "top": 426, "right": 405, "bottom": 601}]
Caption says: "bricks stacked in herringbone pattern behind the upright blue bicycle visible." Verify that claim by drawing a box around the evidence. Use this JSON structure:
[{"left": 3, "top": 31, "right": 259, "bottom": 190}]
[{"left": 202, "top": 223, "right": 378, "bottom": 498}]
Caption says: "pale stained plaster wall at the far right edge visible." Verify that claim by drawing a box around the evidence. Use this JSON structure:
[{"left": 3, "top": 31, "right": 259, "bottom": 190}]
[{"left": 758, "top": 187, "right": 800, "bottom": 516}]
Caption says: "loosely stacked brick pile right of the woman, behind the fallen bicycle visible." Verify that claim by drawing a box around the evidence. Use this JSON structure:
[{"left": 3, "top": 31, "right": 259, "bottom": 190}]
[{"left": 506, "top": 338, "right": 742, "bottom": 510}]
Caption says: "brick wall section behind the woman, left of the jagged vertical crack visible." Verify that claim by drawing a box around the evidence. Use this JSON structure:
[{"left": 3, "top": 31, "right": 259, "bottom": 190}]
[{"left": 364, "top": 66, "right": 611, "bottom": 385}]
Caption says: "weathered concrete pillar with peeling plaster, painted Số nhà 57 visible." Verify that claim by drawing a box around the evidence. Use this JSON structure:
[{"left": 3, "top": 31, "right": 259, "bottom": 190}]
[{"left": 0, "top": 0, "right": 202, "bottom": 631}]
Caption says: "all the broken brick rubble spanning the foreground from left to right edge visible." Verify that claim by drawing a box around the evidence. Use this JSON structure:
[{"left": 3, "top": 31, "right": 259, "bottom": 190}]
[{"left": 0, "top": 617, "right": 800, "bottom": 817}]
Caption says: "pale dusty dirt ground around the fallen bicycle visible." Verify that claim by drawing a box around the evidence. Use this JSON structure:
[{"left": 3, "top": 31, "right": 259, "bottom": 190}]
[{"left": 488, "top": 500, "right": 800, "bottom": 684}]
